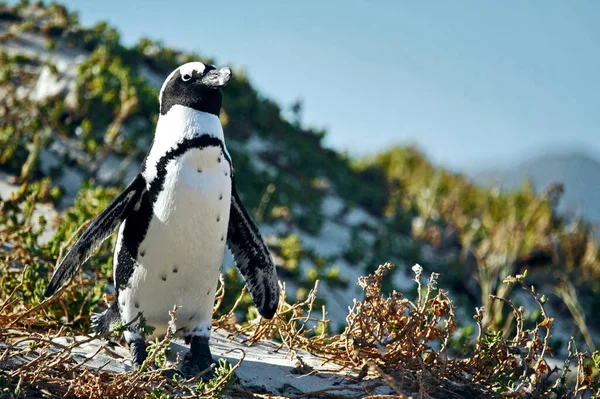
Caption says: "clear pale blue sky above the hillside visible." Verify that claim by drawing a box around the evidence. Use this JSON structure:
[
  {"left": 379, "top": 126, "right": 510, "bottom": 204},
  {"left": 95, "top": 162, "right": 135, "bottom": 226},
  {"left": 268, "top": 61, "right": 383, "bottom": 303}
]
[{"left": 57, "top": 0, "right": 600, "bottom": 170}]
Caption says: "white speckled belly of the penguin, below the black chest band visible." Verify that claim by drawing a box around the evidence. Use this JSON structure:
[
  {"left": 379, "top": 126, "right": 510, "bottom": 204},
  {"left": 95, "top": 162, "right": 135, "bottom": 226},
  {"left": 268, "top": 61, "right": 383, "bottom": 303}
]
[{"left": 119, "top": 147, "right": 231, "bottom": 335}]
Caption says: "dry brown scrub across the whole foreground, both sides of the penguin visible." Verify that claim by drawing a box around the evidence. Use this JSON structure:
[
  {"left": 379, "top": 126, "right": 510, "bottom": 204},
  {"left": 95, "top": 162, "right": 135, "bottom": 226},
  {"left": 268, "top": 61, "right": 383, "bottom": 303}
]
[{"left": 0, "top": 256, "right": 600, "bottom": 398}]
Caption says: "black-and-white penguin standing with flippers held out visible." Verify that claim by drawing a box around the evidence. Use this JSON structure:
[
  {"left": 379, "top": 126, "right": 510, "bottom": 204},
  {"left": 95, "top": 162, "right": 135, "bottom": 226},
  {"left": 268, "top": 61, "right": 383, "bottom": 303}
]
[{"left": 45, "top": 62, "right": 279, "bottom": 376}]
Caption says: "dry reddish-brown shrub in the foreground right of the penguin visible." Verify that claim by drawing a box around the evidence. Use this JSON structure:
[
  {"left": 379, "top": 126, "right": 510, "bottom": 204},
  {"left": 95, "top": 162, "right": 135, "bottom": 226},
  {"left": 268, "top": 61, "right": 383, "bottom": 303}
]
[{"left": 217, "top": 264, "right": 600, "bottom": 398}]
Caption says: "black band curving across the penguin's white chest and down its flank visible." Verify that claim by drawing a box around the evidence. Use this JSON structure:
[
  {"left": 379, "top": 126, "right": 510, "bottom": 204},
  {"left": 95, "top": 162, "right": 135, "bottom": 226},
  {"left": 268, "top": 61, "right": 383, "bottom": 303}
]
[{"left": 115, "top": 134, "right": 231, "bottom": 294}]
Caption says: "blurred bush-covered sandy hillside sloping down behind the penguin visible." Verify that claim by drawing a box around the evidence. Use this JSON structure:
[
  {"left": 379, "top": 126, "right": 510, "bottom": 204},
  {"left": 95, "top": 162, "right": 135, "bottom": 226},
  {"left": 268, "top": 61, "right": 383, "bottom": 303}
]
[{"left": 0, "top": 0, "right": 600, "bottom": 360}]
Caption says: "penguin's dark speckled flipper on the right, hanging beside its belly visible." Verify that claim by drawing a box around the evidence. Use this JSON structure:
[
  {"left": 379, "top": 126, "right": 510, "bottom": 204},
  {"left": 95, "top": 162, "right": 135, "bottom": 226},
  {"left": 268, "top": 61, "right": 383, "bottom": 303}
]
[{"left": 227, "top": 177, "right": 279, "bottom": 319}]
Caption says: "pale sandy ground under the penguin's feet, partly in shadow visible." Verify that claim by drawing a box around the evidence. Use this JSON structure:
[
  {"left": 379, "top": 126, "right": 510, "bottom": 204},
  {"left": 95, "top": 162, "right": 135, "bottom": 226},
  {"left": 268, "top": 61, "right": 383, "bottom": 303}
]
[{"left": 0, "top": 329, "right": 393, "bottom": 398}]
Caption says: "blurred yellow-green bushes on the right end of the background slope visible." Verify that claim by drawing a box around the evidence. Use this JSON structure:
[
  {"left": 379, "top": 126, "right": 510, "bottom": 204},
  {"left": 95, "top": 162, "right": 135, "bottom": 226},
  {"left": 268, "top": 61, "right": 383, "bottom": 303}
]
[{"left": 358, "top": 148, "right": 600, "bottom": 334}]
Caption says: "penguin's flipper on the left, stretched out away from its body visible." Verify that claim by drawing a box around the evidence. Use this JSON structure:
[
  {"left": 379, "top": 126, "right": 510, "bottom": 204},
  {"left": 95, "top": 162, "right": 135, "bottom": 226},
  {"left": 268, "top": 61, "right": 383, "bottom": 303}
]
[{"left": 44, "top": 174, "right": 146, "bottom": 298}]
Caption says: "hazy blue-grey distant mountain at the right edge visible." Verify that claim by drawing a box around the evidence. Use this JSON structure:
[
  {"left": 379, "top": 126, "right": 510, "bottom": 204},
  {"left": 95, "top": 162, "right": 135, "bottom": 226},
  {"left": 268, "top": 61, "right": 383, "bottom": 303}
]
[{"left": 469, "top": 151, "right": 600, "bottom": 230}]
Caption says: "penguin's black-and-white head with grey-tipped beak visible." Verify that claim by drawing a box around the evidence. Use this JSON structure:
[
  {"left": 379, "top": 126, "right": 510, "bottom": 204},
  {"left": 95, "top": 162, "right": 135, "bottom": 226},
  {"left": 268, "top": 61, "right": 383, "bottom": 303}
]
[{"left": 159, "top": 62, "right": 231, "bottom": 116}]
